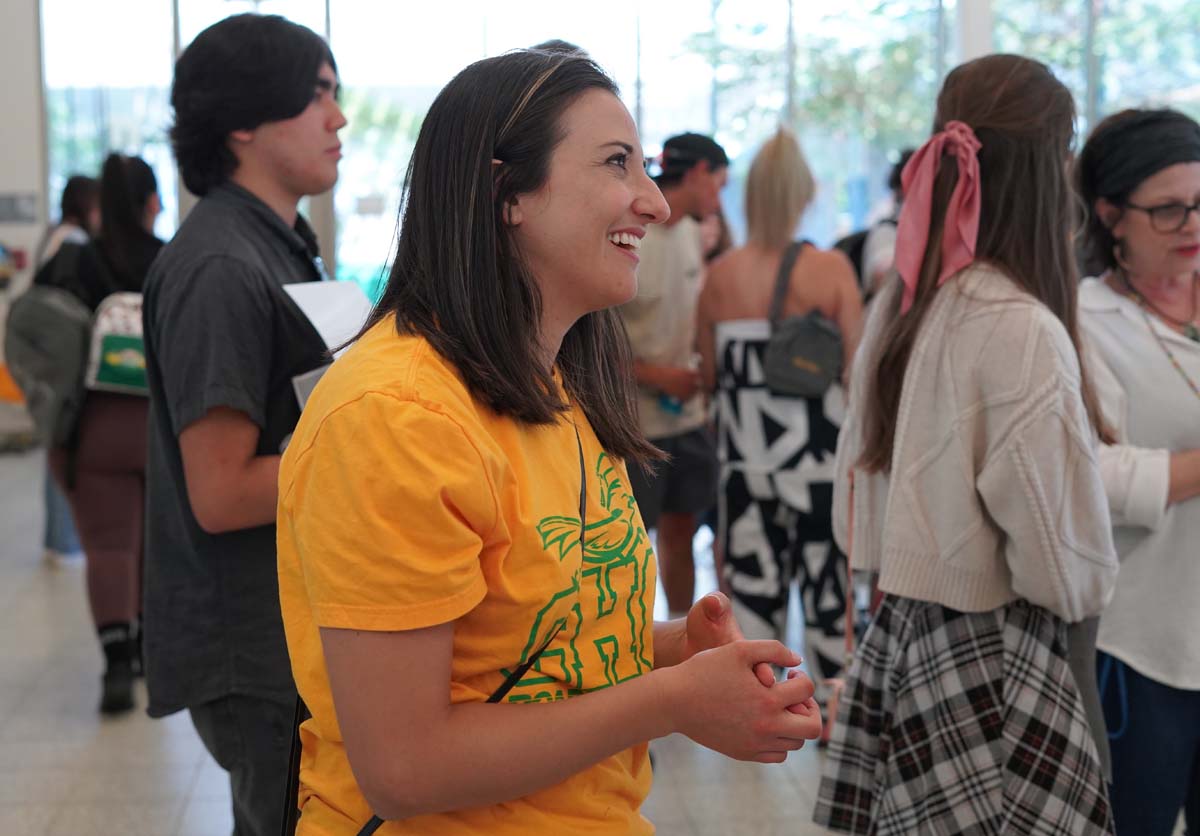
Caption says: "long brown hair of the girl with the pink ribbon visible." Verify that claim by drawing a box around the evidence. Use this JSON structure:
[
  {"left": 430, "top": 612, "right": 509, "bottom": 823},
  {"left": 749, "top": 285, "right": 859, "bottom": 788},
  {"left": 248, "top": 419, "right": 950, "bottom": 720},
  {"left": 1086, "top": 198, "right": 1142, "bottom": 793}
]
[{"left": 859, "top": 55, "right": 1106, "bottom": 473}]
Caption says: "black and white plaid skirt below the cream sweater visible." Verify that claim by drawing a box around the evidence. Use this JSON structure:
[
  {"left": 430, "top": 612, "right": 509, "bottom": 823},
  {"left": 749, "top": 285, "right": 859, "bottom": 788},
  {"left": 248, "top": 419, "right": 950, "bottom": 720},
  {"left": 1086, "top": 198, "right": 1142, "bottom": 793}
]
[{"left": 814, "top": 595, "right": 1112, "bottom": 836}]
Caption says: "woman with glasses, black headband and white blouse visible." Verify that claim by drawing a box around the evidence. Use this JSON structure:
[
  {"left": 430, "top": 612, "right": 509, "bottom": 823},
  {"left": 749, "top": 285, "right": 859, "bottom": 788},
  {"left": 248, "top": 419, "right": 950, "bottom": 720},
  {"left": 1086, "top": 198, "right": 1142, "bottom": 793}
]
[{"left": 1076, "top": 110, "right": 1200, "bottom": 836}]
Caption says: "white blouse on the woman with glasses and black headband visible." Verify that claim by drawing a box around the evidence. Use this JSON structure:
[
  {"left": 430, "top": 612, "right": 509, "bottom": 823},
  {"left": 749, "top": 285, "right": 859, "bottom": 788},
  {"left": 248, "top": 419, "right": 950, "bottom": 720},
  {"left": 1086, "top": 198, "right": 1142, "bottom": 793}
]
[{"left": 1079, "top": 278, "right": 1200, "bottom": 690}]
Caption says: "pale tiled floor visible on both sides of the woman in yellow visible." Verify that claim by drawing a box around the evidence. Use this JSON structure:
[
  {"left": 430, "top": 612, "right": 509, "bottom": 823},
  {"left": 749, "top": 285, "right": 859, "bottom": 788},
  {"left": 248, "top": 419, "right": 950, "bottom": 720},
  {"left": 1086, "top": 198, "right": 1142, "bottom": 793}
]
[{"left": 0, "top": 453, "right": 822, "bottom": 836}]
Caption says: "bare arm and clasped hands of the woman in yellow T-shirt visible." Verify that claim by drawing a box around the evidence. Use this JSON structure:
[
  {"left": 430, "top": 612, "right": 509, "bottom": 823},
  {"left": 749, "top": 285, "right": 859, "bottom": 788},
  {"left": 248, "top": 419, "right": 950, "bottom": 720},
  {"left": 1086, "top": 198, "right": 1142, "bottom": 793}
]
[{"left": 322, "top": 618, "right": 820, "bottom": 819}]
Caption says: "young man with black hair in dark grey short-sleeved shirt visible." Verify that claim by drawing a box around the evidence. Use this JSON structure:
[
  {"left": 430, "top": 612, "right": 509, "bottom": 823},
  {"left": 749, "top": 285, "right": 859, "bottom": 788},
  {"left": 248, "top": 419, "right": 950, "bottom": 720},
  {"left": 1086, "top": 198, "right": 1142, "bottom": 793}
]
[{"left": 144, "top": 14, "right": 346, "bottom": 836}]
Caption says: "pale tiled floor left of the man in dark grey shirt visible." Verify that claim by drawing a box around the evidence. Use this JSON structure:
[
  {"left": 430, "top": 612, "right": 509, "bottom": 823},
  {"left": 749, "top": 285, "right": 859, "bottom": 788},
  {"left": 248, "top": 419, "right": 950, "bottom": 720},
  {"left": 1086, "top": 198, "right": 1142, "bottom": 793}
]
[{"left": 0, "top": 453, "right": 233, "bottom": 836}]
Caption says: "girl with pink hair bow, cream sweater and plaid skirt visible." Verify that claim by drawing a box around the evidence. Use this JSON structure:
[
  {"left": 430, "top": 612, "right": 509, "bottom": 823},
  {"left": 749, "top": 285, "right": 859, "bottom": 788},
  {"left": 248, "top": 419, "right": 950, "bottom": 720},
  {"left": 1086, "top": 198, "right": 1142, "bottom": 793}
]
[{"left": 815, "top": 55, "right": 1117, "bottom": 836}]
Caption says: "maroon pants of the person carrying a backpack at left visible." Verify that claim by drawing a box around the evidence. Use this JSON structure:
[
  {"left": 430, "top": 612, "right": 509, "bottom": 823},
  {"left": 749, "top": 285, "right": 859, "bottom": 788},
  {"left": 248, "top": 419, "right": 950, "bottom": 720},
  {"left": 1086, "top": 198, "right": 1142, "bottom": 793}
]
[{"left": 50, "top": 392, "right": 149, "bottom": 627}]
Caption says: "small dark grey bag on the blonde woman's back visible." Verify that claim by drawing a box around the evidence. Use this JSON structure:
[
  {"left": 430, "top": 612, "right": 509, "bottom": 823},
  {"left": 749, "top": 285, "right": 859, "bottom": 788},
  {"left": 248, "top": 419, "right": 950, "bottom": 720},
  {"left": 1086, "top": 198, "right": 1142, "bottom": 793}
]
[{"left": 762, "top": 241, "right": 842, "bottom": 398}]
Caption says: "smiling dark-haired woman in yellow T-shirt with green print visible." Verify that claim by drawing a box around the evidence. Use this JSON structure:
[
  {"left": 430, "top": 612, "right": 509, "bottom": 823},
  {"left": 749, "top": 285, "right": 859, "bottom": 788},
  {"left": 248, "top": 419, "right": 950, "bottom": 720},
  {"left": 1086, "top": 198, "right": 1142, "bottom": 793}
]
[{"left": 278, "top": 50, "right": 821, "bottom": 836}]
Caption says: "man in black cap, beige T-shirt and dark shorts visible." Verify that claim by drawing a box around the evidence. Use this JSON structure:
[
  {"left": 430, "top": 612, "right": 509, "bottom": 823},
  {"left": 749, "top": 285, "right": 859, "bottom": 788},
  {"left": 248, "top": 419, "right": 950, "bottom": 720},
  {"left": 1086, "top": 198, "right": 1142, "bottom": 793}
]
[{"left": 620, "top": 133, "right": 730, "bottom": 617}]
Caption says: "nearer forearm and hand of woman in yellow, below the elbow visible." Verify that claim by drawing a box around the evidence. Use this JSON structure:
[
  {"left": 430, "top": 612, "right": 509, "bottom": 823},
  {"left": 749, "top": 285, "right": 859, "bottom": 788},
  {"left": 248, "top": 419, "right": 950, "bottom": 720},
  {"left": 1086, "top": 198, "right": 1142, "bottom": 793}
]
[{"left": 364, "top": 642, "right": 821, "bottom": 818}]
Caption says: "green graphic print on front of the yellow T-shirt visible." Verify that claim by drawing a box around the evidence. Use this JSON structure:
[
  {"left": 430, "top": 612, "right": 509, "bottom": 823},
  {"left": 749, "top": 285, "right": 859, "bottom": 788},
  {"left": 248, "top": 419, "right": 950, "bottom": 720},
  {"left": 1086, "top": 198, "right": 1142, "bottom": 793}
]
[{"left": 504, "top": 453, "right": 654, "bottom": 703}]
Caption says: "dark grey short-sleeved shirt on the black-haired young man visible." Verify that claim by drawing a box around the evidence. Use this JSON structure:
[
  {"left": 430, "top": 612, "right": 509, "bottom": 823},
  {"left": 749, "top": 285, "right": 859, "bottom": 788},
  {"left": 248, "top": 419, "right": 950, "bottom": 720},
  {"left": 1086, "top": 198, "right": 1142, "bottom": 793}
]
[{"left": 143, "top": 184, "right": 328, "bottom": 717}]
